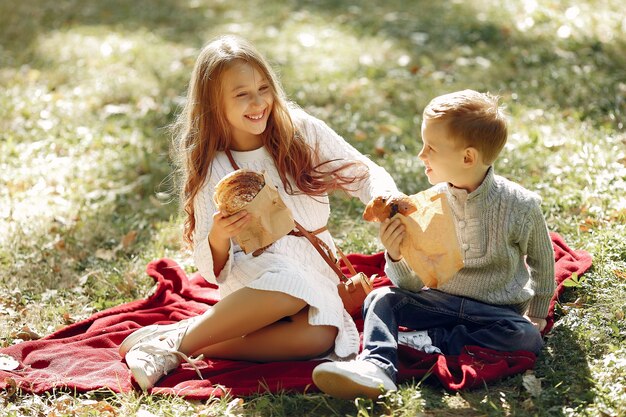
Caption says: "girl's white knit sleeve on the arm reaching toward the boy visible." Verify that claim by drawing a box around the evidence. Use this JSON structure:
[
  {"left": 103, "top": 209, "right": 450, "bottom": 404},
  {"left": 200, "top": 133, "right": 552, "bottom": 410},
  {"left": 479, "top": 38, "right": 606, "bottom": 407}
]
[{"left": 296, "top": 111, "right": 398, "bottom": 204}]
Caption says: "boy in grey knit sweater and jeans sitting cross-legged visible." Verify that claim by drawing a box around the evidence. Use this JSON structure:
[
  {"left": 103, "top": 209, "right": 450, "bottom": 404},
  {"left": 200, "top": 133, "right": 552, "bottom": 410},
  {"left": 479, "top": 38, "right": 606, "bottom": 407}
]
[{"left": 313, "top": 90, "right": 555, "bottom": 399}]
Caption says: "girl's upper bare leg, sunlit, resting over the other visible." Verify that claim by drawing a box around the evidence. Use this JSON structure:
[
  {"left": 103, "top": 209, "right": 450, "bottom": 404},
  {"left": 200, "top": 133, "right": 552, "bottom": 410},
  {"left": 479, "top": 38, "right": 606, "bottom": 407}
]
[{"left": 179, "top": 288, "right": 307, "bottom": 354}]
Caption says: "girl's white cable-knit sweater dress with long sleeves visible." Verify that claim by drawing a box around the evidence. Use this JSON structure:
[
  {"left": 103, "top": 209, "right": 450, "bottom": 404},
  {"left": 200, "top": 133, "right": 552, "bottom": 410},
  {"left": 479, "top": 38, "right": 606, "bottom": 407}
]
[{"left": 193, "top": 110, "right": 397, "bottom": 358}]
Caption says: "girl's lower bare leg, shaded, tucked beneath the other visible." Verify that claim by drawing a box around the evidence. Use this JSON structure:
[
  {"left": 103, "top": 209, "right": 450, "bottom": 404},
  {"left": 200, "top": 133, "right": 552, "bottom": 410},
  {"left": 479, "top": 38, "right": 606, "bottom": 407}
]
[{"left": 194, "top": 308, "right": 337, "bottom": 362}]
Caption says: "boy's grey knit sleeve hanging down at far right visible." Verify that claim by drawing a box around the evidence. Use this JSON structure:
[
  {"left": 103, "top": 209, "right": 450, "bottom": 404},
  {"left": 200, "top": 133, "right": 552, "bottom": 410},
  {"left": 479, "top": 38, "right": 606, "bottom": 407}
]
[{"left": 523, "top": 204, "right": 556, "bottom": 318}]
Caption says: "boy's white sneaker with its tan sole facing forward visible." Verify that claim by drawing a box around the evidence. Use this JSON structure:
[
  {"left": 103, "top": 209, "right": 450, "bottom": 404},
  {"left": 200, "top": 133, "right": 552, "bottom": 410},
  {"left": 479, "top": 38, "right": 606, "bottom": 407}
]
[{"left": 313, "top": 360, "right": 398, "bottom": 400}]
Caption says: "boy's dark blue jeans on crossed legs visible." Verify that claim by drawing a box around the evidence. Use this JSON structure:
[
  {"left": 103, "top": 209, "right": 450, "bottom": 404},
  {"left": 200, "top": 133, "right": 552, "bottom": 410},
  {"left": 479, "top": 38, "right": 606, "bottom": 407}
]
[{"left": 360, "top": 287, "right": 543, "bottom": 381}]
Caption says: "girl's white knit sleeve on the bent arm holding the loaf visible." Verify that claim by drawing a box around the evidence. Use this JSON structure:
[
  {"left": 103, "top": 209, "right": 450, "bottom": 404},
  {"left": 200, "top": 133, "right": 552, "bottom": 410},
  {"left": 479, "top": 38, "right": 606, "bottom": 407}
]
[{"left": 193, "top": 177, "right": 233, "bottom": 284}]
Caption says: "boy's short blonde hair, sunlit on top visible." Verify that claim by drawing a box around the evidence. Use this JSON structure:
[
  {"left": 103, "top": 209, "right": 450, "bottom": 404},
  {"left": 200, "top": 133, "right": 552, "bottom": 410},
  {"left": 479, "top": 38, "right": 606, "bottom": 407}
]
[{"left": 424, "top": 90, "right": 507, "bottom": 165}]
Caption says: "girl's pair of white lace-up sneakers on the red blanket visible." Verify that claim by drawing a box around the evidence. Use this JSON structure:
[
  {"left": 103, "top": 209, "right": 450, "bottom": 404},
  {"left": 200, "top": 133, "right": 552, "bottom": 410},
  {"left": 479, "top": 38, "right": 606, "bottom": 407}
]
[{"left": 125, "top": 321, "right": 202, "bottom": 391}]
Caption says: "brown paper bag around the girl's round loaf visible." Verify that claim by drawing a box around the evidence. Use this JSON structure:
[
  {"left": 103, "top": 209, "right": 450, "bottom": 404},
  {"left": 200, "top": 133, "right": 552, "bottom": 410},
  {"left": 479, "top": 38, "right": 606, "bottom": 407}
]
[{"left": 235, "top": 172, "right": 295, "bottom": 254}]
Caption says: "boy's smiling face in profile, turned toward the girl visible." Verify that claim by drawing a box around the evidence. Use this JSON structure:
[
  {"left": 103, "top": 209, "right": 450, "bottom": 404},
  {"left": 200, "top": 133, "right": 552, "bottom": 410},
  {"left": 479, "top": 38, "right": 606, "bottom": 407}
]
[{"left": 418, "top": 118, "right": 467, "bottom": 186}]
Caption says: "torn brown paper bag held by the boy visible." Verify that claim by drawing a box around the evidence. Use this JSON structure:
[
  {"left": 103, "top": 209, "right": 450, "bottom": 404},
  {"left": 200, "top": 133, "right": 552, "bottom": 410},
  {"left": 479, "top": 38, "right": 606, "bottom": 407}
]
[{"left": 396, "top": 189, "right": 463, "bottom": 288}]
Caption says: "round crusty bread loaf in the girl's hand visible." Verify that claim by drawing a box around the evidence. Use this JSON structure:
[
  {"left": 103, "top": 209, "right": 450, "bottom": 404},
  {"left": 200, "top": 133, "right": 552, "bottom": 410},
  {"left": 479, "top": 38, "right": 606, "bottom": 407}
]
[{"left": 214, "top": 169, "right": 265, "bottom": 216}]
